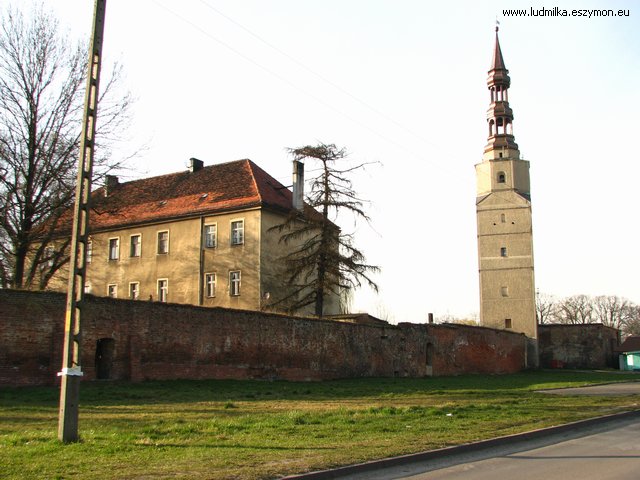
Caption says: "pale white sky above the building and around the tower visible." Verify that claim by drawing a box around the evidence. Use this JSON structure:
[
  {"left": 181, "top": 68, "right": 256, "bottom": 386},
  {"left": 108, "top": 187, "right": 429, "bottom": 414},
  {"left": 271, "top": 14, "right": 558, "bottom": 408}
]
[{"left": 32, "top": 0, "right": 640, "bottom": 323}]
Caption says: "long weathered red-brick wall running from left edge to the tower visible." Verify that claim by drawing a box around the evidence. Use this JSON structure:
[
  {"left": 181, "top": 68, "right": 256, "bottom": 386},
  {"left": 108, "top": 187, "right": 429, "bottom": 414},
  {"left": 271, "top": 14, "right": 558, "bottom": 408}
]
[{"left": 0, "top": 290, "right": 525, "bottom": 385}]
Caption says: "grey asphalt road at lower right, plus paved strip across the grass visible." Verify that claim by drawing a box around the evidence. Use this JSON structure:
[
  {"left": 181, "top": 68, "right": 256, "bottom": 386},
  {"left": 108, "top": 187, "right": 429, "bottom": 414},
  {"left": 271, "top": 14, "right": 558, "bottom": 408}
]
[{"left": 287, "top": 382, "right": 640, "bottom": 480}]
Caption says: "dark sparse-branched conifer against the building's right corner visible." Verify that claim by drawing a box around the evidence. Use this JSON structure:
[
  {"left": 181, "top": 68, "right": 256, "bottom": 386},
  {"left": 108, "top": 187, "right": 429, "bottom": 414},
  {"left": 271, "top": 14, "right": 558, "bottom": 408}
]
[{"left": 271, "top": 144, "right": 379, "bottom": 317}]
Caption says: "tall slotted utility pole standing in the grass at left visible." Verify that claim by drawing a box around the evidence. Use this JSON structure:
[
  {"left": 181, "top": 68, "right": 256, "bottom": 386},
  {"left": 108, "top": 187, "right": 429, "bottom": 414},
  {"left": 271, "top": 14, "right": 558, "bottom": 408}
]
[{"left": 58, "top": 0, "right": 107, "bottom": 443}]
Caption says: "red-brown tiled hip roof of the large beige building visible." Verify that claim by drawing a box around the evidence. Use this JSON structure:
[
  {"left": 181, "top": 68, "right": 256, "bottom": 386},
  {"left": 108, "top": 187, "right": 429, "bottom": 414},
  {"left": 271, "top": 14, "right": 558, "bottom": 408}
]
[{"left": 84, "top": 160, "right": 292, "bottom": 231}]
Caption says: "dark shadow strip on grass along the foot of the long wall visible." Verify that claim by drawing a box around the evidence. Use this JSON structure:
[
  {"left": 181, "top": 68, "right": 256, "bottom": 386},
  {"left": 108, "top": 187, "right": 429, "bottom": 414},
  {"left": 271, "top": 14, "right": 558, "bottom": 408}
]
[{"left": 0, "top": 371, "right": 635, "bottom": 409}]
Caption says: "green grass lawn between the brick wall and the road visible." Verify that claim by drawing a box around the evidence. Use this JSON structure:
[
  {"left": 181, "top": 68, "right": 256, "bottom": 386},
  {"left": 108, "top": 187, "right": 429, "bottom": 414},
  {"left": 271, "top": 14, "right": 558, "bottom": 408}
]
[{"left": 0, "top": 371, "right": 640, "bottom": 480}]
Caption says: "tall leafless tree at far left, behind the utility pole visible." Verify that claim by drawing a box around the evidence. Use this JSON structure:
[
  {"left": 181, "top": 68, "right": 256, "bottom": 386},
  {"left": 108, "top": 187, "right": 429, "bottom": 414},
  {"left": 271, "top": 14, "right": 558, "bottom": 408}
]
[{"left": 0, "top": 4, "right": 132, "bottom": 288}]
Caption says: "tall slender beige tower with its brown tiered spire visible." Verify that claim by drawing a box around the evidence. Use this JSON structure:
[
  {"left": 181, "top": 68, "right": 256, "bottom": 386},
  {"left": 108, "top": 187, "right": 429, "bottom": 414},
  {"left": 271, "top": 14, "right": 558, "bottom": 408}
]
[{"left": 476, "top": 27, "right": 537, "bottom": 339}]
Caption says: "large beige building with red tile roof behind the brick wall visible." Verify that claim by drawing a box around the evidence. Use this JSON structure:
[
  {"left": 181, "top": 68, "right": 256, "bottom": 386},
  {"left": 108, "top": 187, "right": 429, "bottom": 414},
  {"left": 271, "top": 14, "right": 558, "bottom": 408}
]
[{"left": 50, "top": 158, "right": 339, "bottom": 315}]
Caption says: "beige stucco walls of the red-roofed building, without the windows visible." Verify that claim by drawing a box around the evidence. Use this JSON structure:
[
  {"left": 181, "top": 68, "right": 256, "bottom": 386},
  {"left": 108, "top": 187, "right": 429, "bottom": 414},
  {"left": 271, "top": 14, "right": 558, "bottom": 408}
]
[{"left": 49, "top": 208, "right": 339, "bottom": 315}]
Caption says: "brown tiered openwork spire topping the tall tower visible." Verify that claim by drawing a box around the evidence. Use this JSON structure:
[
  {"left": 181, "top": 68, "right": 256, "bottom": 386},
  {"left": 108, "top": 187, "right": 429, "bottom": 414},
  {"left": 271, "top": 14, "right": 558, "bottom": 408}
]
[{"left": 484, "top": 25, "right": 520, "bottom": 160}]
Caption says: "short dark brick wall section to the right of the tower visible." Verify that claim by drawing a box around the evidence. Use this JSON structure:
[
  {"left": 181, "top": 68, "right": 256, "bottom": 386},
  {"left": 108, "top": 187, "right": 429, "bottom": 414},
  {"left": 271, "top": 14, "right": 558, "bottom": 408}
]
[{"left": 538, "top": 323, "right": 620, "bottom": 368}]
